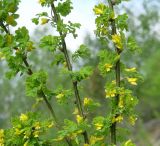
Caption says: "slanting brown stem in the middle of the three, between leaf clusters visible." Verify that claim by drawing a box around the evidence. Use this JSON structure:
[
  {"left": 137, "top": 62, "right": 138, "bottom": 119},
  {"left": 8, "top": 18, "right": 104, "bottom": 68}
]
[{"left": 51, "top": 2, "right": 89, "bottom": 144}]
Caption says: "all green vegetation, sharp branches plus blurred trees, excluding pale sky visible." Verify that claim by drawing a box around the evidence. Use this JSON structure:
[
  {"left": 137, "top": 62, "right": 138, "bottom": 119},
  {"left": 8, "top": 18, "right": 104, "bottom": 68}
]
[{"left": 0, "top": 0, "right": 160, "bottom": 146}]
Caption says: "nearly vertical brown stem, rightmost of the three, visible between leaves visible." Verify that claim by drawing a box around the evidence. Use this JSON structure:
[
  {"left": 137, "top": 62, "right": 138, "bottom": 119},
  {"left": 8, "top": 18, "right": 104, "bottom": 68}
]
[{"left": 108, "top": 0, "right": 121, "bottom": 145}]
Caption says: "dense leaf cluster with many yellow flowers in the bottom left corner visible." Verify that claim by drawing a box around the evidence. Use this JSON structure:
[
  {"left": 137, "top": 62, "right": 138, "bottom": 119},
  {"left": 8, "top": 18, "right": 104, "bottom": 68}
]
[{"left": 3, "top": 112, "right": 54, "bottom": 146}]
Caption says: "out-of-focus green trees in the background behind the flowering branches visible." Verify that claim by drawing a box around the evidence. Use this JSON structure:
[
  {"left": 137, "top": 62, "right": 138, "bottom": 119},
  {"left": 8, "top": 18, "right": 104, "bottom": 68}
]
[{"left": 0, "top": 0, "right": 160, "bottom": 146}]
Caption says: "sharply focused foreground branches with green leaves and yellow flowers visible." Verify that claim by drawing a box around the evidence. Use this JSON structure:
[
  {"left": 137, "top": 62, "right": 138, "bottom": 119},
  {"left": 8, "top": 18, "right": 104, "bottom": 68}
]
[{"left": 0, "top": 0, "right": 141, "bottom": 146}]
